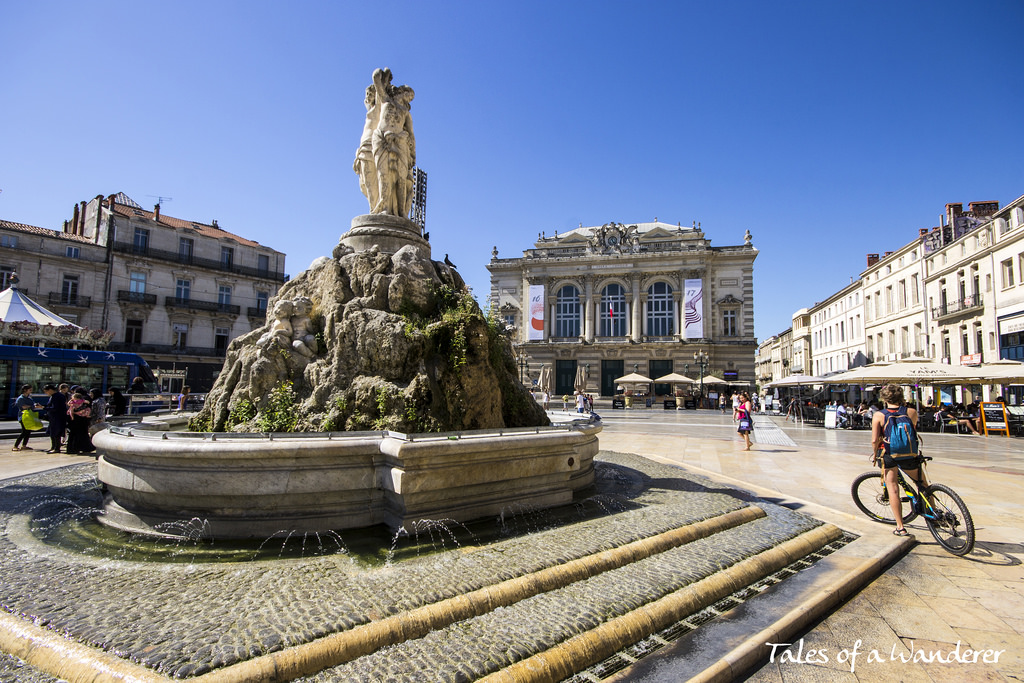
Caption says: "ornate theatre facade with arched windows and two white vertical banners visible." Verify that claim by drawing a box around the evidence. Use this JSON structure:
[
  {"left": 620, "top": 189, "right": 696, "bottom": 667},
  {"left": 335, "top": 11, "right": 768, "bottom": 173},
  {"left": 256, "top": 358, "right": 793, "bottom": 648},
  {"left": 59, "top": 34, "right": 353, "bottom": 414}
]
[{"left": 487, "top": 221, "right": 758, "bottom": 395}]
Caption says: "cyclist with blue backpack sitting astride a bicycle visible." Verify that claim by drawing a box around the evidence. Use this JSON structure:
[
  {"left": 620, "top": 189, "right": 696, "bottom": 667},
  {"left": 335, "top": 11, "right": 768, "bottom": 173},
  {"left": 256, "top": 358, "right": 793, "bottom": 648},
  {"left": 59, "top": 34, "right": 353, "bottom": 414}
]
[{"left": 871, "top": 384, "right": 924, "bottom": 536}]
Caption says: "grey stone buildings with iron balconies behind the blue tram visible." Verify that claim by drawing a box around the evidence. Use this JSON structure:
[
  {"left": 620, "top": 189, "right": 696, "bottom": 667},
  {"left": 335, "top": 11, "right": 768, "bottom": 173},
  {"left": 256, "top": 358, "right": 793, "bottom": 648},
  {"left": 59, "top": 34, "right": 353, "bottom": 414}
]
[{"left": 0, "top": 194, "right": 288, "bottom": 392}]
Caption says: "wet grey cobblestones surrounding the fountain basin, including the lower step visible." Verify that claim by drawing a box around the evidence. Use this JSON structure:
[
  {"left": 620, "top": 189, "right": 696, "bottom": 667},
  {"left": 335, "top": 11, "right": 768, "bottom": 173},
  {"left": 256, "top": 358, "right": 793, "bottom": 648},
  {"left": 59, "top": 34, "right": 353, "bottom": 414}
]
[{"left": 0, "top": 453, "right": 818, "bottom": 681}]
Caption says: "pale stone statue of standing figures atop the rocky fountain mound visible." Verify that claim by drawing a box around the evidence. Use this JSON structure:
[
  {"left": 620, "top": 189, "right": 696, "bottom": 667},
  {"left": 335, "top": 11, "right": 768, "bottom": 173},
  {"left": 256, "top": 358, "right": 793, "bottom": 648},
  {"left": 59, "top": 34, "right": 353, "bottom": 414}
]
[{"left": 352, "top": 69, "right": 416, "bottom": 218}]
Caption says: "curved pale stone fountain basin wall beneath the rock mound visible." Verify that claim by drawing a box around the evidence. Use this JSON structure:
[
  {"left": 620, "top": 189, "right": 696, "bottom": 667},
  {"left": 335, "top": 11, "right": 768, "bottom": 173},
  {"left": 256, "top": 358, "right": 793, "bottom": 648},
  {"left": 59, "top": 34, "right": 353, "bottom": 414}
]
[{"left": 93, "top": 423, "right": 601, "bottom": 539}]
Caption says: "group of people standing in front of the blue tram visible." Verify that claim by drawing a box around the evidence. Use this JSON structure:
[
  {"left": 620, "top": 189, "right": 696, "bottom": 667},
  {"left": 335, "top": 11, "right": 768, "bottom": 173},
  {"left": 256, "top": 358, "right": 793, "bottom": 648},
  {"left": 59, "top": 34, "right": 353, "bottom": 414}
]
[{"left": 11, "top": 384, "right": 128, "bottom": 455}]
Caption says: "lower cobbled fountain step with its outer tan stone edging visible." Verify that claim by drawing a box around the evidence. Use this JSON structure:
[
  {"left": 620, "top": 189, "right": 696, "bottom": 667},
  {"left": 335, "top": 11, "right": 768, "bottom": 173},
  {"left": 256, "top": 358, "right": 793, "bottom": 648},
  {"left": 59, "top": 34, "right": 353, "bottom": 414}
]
[{"left": 290, "top": 516, "right": 842, "bottom": 683}]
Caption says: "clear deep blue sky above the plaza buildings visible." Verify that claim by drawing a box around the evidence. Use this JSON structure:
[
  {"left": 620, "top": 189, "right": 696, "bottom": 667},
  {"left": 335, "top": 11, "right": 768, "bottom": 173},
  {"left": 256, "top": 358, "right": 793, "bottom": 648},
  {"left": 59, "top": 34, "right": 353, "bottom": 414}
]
[{"left": 0, "top": 0, "right": 1024, "bottom": 338}]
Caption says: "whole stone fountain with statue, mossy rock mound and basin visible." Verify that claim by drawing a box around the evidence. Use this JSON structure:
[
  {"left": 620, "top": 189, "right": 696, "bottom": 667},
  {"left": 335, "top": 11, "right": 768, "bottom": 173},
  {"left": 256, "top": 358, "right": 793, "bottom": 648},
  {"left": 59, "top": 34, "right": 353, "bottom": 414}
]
[{"left": 94, "top": 69, "right": 600, "bottom": 538}]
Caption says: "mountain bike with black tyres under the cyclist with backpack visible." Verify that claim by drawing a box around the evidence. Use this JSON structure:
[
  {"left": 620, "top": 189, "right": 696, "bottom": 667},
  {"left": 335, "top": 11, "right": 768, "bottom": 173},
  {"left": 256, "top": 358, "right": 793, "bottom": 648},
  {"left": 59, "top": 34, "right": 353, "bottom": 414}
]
[{"left": 850, "top": 456, "right": 974, "bottom": 556}]
